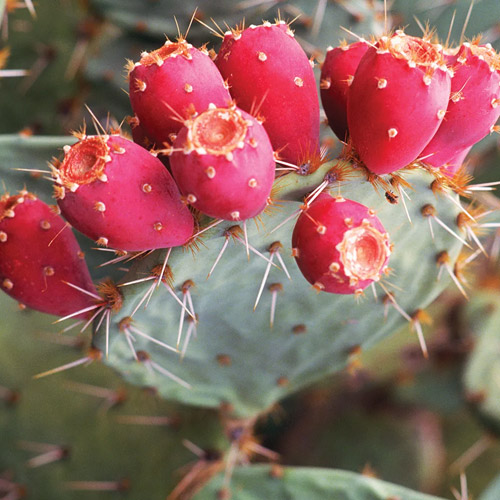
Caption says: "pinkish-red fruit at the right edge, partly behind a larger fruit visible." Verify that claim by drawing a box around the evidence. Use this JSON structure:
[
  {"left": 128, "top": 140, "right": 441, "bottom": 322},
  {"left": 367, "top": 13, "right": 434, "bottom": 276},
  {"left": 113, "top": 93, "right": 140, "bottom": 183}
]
[{"left": 421, "top": 42, "right": 500, "bottom": 167}]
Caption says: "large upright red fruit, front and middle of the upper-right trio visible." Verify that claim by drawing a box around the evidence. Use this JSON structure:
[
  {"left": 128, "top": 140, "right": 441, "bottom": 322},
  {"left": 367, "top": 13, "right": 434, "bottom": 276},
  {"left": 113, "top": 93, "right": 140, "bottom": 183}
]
[{"left": 347, "top": 31, "right": 451, "bottom": 175}]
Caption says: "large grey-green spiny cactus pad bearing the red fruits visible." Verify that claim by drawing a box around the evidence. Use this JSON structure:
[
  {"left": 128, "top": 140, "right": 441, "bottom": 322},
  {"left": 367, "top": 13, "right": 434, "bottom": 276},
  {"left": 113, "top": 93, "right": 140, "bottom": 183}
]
[{"left": 94, "top": 164, "right": 461, "bottom": 417}]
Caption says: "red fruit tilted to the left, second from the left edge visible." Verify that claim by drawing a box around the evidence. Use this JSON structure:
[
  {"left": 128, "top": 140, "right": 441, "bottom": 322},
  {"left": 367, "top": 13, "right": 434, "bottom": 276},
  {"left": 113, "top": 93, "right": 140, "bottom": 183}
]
[{"left": 53, "top": 135, "right": 194, "bottom": 251}]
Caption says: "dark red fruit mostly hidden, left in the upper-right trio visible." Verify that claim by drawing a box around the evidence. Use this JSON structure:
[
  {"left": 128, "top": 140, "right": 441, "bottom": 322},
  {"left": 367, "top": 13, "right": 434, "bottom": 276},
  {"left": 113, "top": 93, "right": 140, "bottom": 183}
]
[{"left": 320, "top": 41, "right": 370, "bottom": 141}]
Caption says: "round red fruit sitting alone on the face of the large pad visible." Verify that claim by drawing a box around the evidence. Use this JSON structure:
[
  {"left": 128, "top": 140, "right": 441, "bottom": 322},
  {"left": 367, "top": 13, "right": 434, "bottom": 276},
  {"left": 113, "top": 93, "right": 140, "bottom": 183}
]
[{"left": 292, "top": 193, "right": 391, "bottom": 294}]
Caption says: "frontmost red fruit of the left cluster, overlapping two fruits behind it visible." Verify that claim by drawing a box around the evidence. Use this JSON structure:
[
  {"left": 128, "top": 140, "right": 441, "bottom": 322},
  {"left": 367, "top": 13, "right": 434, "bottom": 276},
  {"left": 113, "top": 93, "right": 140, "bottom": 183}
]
[{"left": 170, "top": 106, "right": 275, "bottom": 220}]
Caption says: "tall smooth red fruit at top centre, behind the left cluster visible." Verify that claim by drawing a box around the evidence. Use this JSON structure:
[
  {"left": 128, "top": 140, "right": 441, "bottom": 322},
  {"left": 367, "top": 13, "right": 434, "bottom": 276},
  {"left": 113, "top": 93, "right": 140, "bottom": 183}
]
[{"left": 215, "top": 21, "right": 319, "bottom": 165}]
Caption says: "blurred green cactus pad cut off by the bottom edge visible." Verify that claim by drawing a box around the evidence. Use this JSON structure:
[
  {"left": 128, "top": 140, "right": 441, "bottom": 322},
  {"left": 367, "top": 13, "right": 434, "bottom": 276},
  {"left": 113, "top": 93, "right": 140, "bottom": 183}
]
[{"left": 193, "top": 465, "right": 446, "bottom": 500}]
